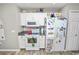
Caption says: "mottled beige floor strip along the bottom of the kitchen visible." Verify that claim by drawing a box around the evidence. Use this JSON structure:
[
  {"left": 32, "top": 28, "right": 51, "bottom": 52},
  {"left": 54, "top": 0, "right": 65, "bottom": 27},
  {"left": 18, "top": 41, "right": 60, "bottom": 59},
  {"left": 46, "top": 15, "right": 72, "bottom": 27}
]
[{"left": 0, "top": 50, "right": 79, "bottom": 55}]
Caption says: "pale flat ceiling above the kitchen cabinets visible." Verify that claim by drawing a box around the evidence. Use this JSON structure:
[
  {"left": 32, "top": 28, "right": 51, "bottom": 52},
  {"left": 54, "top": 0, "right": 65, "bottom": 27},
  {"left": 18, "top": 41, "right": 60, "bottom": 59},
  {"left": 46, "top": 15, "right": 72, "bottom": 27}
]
[{"left": 16, "top": 3, "right": 66, "bottom": 9}]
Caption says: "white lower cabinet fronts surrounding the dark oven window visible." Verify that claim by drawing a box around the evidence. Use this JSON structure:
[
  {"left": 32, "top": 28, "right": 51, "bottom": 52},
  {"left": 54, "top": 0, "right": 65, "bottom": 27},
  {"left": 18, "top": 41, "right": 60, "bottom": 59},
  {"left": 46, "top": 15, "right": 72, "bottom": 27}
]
[{"left": 18, "top": 36, "right": 45, "bottom": 50}]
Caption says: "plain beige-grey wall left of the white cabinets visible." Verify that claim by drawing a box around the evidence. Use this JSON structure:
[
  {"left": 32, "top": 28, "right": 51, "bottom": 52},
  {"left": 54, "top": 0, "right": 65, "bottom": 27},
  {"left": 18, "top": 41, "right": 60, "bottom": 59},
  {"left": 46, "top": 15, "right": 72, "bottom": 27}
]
[{"left": 0, "top": 4, "right": 20, "bottom": 49}]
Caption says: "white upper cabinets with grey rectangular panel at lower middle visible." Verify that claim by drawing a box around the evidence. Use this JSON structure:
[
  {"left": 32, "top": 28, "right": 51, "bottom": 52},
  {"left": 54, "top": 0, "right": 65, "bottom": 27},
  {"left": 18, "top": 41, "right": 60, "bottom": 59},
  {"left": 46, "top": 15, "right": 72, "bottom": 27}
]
[{"left": 20, "top": 13, "right": 47, "bottom": 26}]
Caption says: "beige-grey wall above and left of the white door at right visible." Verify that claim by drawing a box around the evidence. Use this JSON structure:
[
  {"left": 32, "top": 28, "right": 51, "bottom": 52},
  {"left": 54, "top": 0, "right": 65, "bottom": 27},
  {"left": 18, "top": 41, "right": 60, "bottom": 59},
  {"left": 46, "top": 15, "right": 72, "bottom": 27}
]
[{"left": 61, "top": 3, "right": 79, "bottom": 18}]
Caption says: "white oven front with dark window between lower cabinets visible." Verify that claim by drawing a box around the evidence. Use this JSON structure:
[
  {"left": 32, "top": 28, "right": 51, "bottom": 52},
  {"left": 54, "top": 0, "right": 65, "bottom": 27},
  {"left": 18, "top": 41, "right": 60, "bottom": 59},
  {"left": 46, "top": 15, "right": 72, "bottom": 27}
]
[{"left": 26, "top": 35, "right": 40, "bottom": 50}]
